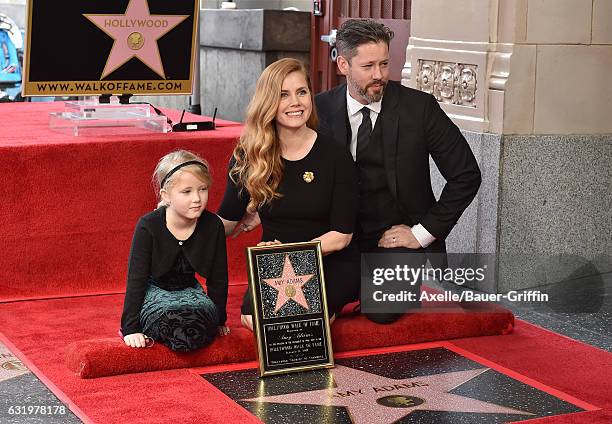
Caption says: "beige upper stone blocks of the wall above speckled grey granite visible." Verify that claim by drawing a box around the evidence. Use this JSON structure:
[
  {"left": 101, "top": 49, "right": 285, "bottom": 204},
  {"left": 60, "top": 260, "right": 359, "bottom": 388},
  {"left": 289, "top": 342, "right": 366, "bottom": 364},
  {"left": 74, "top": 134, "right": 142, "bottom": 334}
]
[{"left": 402, "top": 0, "right": 612, "bottom": 134}]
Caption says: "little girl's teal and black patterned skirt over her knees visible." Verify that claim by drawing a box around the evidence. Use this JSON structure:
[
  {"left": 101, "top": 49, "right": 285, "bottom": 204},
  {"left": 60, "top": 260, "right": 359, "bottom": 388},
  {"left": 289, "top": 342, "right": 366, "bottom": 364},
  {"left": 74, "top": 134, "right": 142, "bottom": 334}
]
[{"left": 140, "top": 281, "right": 219, "bottom": 352}]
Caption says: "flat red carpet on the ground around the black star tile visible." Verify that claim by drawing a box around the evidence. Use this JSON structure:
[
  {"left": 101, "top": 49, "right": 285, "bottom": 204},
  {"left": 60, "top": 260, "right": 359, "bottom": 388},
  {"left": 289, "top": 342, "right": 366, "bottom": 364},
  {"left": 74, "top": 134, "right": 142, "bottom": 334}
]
[{"left": 1, "top": 296, "right": 612, "bottom": 423}]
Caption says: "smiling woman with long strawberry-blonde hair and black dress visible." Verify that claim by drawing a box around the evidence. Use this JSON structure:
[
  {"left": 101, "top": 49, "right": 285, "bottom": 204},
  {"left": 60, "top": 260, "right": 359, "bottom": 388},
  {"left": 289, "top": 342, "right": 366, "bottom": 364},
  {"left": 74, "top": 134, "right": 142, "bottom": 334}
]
[{"left": 218, "top": 59, "right": 360, "bottom": 330}]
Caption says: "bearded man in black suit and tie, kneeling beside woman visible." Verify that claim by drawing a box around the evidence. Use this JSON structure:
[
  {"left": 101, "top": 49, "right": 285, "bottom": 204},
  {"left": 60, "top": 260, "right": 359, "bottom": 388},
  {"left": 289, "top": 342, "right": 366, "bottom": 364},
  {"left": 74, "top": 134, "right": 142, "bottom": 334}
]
[{"left": 315, "top": 19, "right": 480, "bottom": 323}]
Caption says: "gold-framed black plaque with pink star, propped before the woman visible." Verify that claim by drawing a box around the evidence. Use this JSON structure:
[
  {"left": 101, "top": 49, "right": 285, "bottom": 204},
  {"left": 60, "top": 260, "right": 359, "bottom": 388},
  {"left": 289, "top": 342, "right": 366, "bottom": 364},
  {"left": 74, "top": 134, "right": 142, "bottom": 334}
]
[{"left": 247, "top": 241, "right": 334, "bottom": 377}]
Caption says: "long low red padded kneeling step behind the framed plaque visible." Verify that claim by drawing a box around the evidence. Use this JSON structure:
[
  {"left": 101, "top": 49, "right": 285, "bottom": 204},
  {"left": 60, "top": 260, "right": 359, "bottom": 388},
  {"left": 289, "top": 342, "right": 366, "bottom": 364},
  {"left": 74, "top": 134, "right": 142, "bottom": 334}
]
[{"left": 66, "top": 308, "right": 514, "bottom": 378}]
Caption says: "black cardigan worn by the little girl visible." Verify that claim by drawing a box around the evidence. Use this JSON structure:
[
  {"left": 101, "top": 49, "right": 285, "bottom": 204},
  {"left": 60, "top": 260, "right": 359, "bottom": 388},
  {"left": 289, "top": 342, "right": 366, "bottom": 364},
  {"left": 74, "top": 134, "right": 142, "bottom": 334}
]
[{"left": 121, "top": 207, "right": 227, "bottom": 336}]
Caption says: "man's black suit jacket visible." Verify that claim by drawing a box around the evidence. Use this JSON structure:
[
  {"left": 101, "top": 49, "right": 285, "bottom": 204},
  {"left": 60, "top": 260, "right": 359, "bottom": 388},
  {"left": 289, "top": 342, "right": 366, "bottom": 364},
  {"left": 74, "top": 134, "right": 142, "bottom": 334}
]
[{"left": 315, "top": 81, "right": 481, "bottom": 250}]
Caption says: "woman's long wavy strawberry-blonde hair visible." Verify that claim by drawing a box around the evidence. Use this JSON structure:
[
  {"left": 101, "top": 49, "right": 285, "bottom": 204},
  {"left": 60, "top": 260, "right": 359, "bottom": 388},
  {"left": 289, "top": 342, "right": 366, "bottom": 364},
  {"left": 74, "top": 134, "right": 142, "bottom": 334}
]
[{"left": 230, "top": 58, "right": 319, "bottom": 212}]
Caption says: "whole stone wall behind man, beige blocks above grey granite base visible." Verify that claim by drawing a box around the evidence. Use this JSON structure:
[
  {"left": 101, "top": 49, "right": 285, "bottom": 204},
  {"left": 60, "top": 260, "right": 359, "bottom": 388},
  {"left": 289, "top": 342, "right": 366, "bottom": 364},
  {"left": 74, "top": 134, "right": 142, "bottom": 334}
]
[{"left": 402, "top": 0, "right": 612, "bottom": 292}]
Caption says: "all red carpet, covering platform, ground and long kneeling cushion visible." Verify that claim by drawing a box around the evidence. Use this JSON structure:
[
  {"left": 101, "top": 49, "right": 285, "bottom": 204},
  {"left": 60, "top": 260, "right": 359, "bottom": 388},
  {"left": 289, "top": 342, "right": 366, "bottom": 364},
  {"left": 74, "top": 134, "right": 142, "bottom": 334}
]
[{"left": 0, "top": 103, "right": 612, "bottom": 424}]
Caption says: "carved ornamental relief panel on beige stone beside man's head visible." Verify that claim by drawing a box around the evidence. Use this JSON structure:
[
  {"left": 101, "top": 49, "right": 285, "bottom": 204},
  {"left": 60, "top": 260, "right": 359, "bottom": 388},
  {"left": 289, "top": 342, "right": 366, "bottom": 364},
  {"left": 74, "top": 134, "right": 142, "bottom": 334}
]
[{"left": 416, "top": 59, "right": 478, "bottom": 108}]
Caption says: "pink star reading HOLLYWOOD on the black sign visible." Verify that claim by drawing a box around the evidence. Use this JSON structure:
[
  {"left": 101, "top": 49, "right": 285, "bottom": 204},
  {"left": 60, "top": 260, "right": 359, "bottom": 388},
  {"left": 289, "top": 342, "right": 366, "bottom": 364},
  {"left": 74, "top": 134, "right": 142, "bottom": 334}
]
[{"left": 83, "top": 0, "right": 189, "bottom": 79}]
